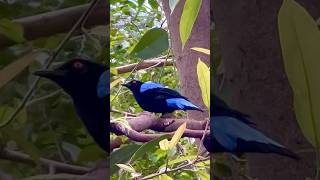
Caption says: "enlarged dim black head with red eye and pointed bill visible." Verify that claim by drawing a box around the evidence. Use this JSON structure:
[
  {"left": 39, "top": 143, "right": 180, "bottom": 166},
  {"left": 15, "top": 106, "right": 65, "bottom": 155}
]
[{"left": 34, "top": 59, "right": 106, "bottom": 96}]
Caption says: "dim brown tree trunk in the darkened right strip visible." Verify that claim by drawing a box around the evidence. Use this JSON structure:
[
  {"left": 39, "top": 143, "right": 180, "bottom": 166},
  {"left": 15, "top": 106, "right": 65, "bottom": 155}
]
[{"left": 213, "top": 0, "right": 320, "bottom": 180}]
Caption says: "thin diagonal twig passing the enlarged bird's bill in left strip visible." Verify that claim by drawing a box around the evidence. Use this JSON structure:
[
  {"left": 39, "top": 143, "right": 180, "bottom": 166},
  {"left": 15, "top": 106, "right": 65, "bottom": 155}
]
[{"left": 1, "top": 0, "right": 99, "bottom": 127}]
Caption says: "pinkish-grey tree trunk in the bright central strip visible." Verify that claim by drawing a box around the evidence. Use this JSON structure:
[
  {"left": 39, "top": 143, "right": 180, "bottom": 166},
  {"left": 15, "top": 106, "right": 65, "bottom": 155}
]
[{"left": 162, "top": 0, "right": 210, "bottom": 119}]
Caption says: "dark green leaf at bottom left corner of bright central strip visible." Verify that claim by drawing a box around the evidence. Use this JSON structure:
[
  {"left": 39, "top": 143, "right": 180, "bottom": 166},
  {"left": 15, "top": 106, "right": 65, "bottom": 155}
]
[{"left": 110, "top": 144, "right": 140, "bottom": 174}]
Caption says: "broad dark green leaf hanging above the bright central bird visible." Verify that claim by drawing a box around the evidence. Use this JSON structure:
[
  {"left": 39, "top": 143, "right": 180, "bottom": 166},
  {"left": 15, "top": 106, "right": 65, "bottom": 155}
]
[{"left": 129, "top": 28, "right": 169, "bottom": 59}]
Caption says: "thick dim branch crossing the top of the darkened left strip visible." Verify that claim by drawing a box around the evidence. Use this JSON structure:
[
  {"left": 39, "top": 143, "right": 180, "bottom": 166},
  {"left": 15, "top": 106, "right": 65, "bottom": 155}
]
[{"left": 0, "top": 0, "right": 109, "bottom": 49}]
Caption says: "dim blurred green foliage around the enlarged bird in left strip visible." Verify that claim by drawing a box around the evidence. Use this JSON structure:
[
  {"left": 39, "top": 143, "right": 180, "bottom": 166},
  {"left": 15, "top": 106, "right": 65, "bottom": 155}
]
[{"left": 0, "top": 0, "right": 109, "bottom": 179}]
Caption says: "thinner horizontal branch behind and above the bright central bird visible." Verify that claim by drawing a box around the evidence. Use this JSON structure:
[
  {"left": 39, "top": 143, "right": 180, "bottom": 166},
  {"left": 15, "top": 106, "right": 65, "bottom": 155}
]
[{"left": 116, "top": 58, "right": 173, "bottom": 74}]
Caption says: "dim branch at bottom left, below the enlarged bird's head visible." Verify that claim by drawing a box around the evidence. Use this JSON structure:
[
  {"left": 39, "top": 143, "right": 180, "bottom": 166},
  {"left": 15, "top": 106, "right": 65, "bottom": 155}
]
[{"left": 0, "top": 149, "right": 90, "bottom": 174}]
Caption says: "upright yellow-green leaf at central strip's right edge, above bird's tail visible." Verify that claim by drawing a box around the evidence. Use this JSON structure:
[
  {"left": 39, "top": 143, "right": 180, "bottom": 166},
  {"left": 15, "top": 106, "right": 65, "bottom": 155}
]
[{"left": 197, "top": 58, "right": 210, "bottom": 109}]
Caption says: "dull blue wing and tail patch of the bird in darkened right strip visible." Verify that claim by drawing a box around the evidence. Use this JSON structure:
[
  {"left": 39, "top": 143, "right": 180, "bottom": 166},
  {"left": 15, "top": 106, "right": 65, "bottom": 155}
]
[{"left": 211, "top": 116, "right": 284, "bottom": 151}]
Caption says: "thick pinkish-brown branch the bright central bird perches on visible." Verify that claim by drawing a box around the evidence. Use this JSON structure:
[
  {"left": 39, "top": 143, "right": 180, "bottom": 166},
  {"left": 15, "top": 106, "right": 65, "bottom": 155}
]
[{"left": 111, "top": 112, "right": 210, "bottom": 150}]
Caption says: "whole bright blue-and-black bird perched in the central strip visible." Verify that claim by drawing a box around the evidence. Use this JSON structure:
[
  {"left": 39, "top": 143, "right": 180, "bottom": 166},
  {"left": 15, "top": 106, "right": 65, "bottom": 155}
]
[{"left": 123, "top": 80, "right": 202, "bottom": 114}]
